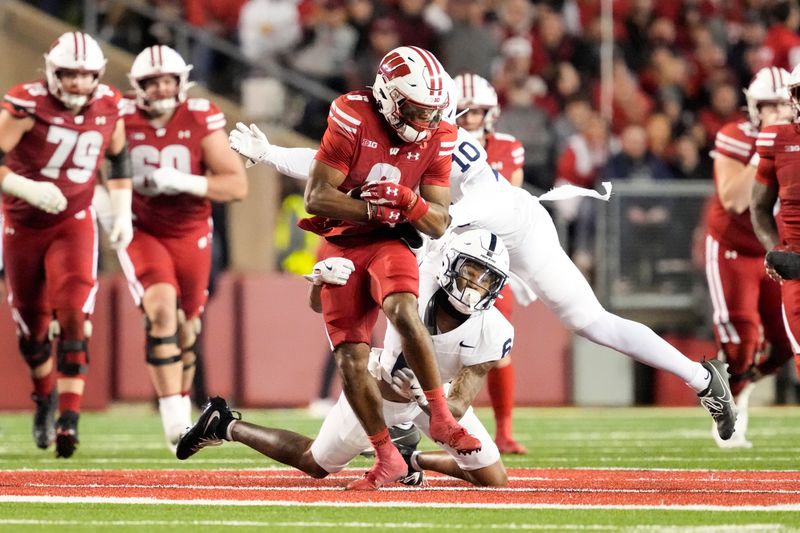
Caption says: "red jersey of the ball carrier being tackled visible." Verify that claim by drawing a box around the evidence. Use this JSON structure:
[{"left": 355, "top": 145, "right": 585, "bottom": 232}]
[{"left": 298, "top": 91, "right": 458, "bottom": 237}]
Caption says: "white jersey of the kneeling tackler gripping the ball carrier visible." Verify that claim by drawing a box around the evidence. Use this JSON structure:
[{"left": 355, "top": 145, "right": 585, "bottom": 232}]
[{"left": 370, "top": 256, "right": 514, "bottom": 383}]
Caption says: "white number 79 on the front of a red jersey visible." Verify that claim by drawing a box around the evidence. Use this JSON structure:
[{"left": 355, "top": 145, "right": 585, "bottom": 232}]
[{"left": 41, "top": 126, "right": 103, "bottom": 183}]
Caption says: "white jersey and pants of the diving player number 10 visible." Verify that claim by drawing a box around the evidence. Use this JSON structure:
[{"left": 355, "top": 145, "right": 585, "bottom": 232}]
[{"left": 268, "top": 128, "right": 607, "bottom": 330}]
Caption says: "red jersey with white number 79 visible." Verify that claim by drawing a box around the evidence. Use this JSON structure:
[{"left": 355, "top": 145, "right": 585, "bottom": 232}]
[{"left": 2, "top": 80, "right": 121, "bottom": 228}]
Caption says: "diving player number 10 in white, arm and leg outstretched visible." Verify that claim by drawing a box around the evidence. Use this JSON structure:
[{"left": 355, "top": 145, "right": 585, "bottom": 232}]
[{"left": 228, "top": 89, "right": 736, "bottom": 440}]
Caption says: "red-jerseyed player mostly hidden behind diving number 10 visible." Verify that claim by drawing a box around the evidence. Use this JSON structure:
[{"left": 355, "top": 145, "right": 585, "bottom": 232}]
[{"left": 454, "top": 74, "right": 528, "bottom": 454}]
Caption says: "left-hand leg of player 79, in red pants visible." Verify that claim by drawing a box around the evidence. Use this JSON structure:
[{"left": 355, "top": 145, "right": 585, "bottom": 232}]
[{"left": 3, "top": 227, "right": 58, "bottom": 449}]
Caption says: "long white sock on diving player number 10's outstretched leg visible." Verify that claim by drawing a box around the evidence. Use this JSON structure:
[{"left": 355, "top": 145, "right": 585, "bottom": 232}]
[{"left": 576, "top": 311, "right": 708, "bottom": 384}]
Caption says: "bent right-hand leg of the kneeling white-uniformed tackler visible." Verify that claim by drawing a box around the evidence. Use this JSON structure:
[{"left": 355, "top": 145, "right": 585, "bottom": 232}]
[{"left": 408, "top": 407, "right": 508, "bottom": 487}]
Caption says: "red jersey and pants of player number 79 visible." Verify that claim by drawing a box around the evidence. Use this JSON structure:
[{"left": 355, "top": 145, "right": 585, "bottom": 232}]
[{"left": 2, "top": 80, "right": 121, "bottom": 330}]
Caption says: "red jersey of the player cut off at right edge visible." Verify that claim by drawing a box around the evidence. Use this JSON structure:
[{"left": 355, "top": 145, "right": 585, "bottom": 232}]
[{"left": 756, "top": 124, "right": 800, "bottom": 246}]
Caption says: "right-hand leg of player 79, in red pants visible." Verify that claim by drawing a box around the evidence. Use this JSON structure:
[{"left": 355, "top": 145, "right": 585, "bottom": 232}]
[{"left": 45, "top": 209, "right": 98, "bottom": 458}]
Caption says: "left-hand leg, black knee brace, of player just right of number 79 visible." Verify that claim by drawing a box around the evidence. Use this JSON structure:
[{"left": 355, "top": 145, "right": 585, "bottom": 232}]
[{"left": 118, "top": 229, "right": 191, "bottom": 449}]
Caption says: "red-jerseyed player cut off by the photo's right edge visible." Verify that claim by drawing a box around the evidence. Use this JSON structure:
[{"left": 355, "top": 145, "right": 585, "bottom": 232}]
[{"left": 750, "top": 63, "right": 800, "bottom": 394}]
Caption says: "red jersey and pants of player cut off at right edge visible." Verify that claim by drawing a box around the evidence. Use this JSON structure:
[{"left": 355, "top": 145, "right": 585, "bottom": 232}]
[{"left": 756, "top": 124, "right": 800, "bottom": 354}]
